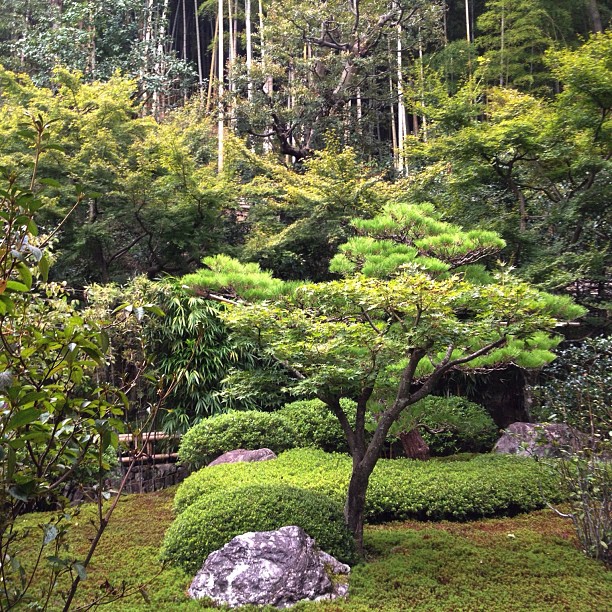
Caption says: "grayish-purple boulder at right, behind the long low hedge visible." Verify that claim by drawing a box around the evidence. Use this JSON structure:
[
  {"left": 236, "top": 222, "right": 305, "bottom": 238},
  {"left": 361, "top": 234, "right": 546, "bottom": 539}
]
[{"left": 493, "top": 422, "right": 588, "bottom": 457}]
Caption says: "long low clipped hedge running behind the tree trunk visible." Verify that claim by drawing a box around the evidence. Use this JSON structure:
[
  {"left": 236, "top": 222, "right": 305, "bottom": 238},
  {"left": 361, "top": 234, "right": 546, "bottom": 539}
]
[{"left": 174, "top": 449, "right": 563, "bottom": 523}]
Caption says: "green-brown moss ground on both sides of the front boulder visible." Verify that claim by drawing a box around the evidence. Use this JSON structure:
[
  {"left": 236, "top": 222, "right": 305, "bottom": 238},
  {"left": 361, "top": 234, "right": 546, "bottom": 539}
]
[{"left": 14, "top": 490, "right": 612, "bottom": 612}]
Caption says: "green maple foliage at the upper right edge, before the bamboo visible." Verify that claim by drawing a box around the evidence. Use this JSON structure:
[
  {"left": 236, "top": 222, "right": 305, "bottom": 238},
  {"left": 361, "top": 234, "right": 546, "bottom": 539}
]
[{"left": 408, "top": 32, "right": 612, "bottom": 308}]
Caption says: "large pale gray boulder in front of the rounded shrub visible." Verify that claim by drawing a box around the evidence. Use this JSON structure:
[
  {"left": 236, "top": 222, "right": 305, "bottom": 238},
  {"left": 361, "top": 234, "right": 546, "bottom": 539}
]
[{"left": 188, "top": 526, "right": 350, "bottom": 608}]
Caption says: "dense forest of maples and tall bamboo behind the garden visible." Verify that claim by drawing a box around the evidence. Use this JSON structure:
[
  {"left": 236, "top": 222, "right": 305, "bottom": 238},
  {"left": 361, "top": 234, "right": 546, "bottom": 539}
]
[{"left": 0, "top": 0, "right": 612, "bottom": 426}]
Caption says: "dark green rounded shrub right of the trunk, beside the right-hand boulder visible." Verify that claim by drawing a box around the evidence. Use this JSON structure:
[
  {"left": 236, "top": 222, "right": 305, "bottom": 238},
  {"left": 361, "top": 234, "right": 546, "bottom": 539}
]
[{"left": 419, "top": 396, "right": 498, "bottom": 455}]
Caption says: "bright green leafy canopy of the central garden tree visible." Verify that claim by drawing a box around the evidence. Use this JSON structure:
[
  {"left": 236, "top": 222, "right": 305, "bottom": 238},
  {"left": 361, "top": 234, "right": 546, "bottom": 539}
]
[{"left": 184, "top": 198, "right": 582, "bottom": 401}]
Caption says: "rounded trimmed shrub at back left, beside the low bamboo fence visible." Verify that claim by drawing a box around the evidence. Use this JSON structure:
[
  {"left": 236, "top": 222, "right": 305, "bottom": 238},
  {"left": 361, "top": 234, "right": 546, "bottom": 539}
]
[{"left": 178, "top": 410, "right": 294, "bottom": 467}]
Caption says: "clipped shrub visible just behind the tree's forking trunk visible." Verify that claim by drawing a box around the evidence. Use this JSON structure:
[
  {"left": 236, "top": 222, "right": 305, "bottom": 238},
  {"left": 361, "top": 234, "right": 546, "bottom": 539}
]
[{"left": 278, "top": 399, "right": 356, "bottom": 453}]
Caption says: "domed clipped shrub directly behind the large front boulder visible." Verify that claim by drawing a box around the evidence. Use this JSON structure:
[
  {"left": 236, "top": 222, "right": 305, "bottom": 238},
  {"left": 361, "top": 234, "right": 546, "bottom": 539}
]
[{"left": 161, "top": 482, "right": 356, "bottom": 573}]
